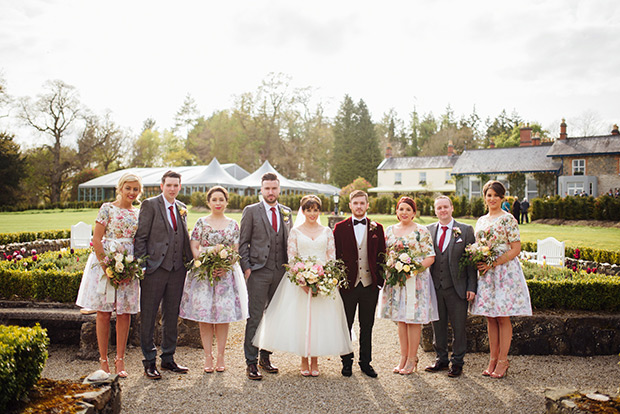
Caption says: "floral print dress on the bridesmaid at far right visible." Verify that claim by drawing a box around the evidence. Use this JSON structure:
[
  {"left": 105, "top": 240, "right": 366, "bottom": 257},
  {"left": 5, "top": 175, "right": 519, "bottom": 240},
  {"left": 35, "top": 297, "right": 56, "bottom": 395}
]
[{"left": 470, "top": 213, "right": 532, "bottom": 317}]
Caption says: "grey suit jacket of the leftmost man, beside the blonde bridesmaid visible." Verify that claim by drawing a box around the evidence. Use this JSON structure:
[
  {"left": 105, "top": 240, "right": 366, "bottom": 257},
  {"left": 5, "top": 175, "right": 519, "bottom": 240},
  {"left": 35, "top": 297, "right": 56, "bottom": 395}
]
[{"left": 134, "top": 194, "right": 193, "bottom": 274}]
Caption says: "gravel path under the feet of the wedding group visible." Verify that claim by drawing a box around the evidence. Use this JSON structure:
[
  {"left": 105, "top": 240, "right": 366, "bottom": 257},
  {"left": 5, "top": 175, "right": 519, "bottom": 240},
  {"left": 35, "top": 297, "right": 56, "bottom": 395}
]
[{"left": 43, "top": 320, "right": 620, "bottom": 413}]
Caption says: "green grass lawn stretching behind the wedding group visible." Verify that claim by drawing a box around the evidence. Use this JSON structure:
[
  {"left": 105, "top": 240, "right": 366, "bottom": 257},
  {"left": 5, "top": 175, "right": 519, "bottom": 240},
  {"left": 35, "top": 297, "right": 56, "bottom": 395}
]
[{"left": 0, "top": 209, "right": 620, "bottom": 250}]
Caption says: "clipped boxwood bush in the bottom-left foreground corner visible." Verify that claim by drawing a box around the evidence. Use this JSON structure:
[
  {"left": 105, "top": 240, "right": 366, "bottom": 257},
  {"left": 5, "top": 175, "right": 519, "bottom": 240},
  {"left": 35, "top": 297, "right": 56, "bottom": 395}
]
[{"left": 0, "top": 324, "right": 49, "bottom": 412}]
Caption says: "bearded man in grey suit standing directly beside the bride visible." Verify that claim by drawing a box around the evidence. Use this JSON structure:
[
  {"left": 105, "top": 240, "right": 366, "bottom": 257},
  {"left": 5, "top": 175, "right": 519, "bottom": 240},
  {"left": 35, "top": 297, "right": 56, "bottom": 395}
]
[{"left": 239, "top": 173, "right": 292, "bottom": 380}]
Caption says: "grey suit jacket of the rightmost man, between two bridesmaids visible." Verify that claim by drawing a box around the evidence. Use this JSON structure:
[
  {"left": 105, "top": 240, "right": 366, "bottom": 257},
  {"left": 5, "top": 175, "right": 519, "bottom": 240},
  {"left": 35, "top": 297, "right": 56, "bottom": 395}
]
[{"left": 427, "top": 220, "right": 478, "bottom": 299}]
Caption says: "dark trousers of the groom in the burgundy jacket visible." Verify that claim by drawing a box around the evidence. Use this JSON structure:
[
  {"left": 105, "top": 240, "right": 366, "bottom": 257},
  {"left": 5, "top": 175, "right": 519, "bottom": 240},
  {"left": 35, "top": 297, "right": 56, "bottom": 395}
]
[{"left": 340, "top": 283, "right": 379, "bottom": 365}]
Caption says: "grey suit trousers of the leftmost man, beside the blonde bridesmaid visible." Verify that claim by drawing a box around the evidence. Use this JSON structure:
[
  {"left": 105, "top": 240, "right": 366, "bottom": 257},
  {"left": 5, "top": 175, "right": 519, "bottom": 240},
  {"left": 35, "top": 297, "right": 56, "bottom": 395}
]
[{"left": 140, "top": 267, "right": 187, "bottom": 366}]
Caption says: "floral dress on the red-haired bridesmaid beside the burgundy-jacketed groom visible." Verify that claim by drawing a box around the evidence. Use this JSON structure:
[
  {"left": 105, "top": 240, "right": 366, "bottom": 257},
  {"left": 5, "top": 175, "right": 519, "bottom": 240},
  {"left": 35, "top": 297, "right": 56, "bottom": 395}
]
[{"left": 379, "top": 225, "right": 439, "bottom": 324}]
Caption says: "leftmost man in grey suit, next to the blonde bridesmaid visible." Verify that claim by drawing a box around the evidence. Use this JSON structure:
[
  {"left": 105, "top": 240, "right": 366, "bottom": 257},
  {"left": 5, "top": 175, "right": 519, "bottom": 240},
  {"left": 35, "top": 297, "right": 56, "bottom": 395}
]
[{"left": 134, "top": 171, "right": 192, "bottom": 379}]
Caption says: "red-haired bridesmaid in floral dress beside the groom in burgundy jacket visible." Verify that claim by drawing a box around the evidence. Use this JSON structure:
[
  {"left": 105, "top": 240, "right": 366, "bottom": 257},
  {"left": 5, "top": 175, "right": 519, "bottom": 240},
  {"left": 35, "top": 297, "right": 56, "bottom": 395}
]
[{"left": 379, "top": 197, "right": 439, "bottom": 375}]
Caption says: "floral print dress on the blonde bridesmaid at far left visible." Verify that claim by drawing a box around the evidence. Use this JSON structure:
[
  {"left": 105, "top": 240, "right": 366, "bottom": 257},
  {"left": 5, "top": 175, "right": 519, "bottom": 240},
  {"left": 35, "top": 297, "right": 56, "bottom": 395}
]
[{"left": 76, "top": 203, "right": 140, "bottom": 314}]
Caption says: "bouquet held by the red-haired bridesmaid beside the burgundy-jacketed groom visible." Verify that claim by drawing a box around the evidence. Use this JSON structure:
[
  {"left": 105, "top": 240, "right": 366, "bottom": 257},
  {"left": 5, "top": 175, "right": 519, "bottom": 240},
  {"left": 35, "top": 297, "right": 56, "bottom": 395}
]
[{"left": 383, "top": 241, "right": 424, "bottom": 286}]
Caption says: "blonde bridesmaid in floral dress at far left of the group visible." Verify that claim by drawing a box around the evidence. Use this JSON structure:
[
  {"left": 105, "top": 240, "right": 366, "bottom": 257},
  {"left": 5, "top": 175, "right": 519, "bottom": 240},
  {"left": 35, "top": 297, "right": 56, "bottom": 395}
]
[{"left": 76, "top": 173, "right": 142, "bottom": 378}]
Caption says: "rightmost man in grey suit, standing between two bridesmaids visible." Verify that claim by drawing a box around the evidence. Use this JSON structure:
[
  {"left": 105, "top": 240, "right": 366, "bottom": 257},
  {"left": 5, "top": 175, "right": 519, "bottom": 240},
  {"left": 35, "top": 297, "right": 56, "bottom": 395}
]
[{"left": 426, "top": 196, "right": 478, "bottom": 377}]
